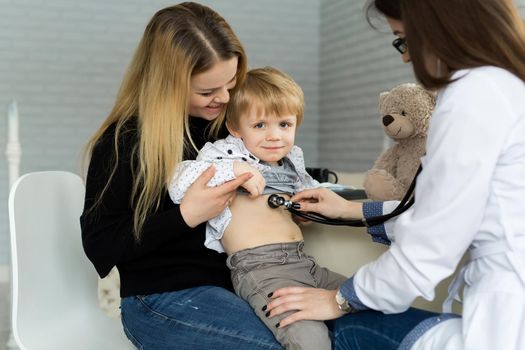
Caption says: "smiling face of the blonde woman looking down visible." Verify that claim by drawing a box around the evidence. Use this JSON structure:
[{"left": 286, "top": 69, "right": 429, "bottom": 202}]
[{"left": 188, "top": 57, "right": 238, "bottom": 120}]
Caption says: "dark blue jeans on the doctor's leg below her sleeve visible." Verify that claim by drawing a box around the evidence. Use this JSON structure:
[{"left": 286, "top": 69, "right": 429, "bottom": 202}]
[{"left": 333, "top": 308, "right": 438, "bottom": 350}]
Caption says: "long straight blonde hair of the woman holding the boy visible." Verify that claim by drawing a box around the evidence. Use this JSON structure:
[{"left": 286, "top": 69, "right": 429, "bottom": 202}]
[{"left": 85, "top": 2, "right": 247, "bottom": 240}]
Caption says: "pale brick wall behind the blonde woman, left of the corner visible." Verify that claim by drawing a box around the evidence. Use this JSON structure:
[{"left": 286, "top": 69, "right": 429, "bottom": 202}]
[{"left": 0, "top": 0, "right": 320, "bottom": 268}]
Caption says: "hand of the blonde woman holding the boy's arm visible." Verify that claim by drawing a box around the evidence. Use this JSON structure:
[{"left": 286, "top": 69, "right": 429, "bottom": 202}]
[{"left": 180, "top": 166, "right": 253, "bottom": 227}]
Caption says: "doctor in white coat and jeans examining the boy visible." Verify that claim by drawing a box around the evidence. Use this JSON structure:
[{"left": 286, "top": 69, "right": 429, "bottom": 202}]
[{"left": 267, "top": 0, "right": 525, "bottom": 350}]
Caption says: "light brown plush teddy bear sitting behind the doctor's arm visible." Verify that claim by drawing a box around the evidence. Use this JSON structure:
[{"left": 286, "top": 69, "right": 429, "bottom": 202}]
[{"left": 363, "top": 83, "right": 436, "bottom": 201}]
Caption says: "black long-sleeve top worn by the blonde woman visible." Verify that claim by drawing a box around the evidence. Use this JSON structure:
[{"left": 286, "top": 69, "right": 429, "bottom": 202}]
[{"left": 80, "top": 118, "right": 232, "bottom": 297}]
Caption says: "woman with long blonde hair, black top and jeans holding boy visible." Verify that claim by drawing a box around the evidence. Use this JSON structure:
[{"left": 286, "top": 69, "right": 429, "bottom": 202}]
[{"left": 81, "top": 2, "right": 280, "bottom": 349}]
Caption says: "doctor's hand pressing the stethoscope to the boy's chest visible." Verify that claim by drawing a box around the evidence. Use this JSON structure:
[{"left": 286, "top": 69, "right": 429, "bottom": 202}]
[{"left": 292, "top": 188, "right": 363, "bottom": 219}]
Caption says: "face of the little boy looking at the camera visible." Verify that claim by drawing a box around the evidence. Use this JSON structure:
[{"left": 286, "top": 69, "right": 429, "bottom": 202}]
[{"left": 228, "top": 108, "right": 297, "bottom": 165}]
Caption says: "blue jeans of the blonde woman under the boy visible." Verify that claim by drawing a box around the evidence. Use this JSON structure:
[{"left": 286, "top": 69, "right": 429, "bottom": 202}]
[{"left": 121, "top": 286, "right": 282, "bottom": 350}]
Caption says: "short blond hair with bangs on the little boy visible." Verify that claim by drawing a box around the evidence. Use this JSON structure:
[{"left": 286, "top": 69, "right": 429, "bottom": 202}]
[{"left": 226, "top": 67, "right": 304, "bottom": 129}]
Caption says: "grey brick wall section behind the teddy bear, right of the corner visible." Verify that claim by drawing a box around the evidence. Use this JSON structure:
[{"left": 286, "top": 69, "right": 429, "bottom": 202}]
[{"left": 319, "top": 0, "right": 414, "bottom": 172}]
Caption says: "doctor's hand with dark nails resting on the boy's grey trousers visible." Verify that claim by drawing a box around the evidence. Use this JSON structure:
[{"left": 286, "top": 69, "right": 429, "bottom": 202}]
[{"left": 265, "top": 287, "right": 345, "bottom": 327}]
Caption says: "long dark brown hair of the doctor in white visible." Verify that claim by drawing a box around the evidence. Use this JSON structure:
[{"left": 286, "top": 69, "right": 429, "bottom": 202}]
[{"left": 400, "top": 0, "right": 525, "bottom": 88}]
